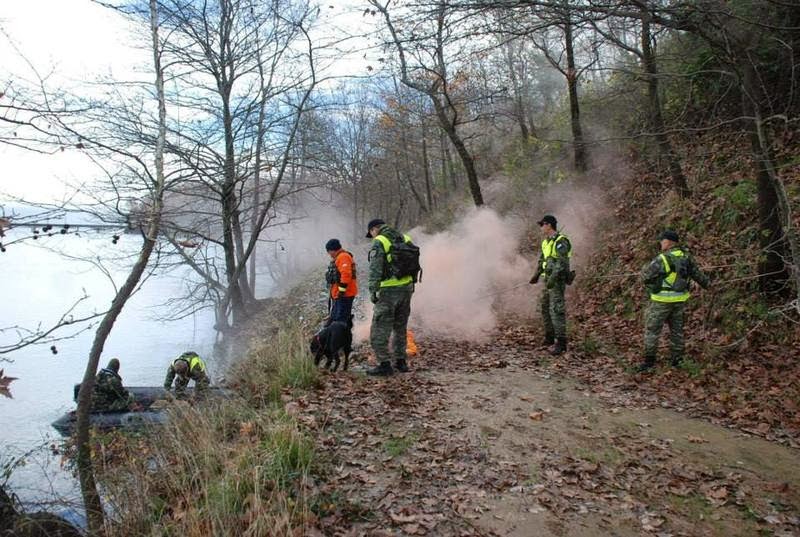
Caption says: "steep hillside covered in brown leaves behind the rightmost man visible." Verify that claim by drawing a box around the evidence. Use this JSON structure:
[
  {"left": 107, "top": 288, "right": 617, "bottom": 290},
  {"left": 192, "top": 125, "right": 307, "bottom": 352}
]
[{"left": 559, "top": 127, "right": 800, "bottom": 446}]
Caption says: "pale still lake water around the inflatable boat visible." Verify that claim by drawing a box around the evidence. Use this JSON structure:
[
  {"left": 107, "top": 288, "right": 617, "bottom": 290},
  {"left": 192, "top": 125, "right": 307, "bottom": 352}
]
[{"left": 0, "top": 230, "right": 221, "bottom": 505}]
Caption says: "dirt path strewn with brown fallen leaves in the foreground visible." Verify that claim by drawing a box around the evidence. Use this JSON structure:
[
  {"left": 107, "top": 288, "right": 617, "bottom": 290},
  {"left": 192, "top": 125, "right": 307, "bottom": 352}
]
[{"left": 296, "top": 324, "right": 800, "bottom": 536}]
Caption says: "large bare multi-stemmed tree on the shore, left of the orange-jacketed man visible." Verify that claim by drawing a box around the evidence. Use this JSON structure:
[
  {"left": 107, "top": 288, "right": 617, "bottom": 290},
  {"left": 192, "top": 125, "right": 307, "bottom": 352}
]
[{"left": 151, "top": 0, "right": 317, "bottom": 330}]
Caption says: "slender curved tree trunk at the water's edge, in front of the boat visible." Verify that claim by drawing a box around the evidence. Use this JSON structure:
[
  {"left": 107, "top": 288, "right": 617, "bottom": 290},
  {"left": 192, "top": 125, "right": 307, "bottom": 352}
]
[{"left": 75, "top": 0, "right": 167, "bottom": 536}]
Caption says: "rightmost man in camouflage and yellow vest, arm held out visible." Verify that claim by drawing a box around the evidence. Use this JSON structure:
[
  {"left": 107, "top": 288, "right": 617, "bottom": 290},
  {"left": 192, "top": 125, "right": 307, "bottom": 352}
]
[{"left": 638, "top": 229, "right": 709, "bottom": 372}]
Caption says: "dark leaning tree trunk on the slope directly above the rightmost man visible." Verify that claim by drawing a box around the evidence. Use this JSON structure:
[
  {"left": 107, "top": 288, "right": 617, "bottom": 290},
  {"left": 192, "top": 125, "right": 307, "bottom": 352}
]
[{"left": 641, "top": 8, "right": 691, "bottom": 198}]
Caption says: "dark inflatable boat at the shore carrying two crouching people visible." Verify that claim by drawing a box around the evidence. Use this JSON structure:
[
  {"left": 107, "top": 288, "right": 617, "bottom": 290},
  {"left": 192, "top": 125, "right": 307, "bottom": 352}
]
[{"left": 52, "top": 384, "right": 232, "bottom": 436}]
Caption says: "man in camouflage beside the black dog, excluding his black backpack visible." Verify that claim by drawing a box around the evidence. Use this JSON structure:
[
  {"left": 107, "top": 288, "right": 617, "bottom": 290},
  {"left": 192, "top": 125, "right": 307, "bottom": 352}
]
[{"left": 367, "top": 219, "right": 414, "bottom": 376}]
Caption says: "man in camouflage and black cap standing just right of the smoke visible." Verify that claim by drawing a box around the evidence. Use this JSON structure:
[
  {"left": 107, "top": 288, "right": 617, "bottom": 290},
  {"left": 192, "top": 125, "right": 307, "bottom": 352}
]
[{"left": 530, "top": 214, "right": 575, "bottom": 355}]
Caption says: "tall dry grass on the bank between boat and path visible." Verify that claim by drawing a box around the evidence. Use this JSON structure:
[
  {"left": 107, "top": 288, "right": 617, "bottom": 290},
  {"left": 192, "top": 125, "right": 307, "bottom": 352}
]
[{"left": 96, "top": 325, "right": 324, "bottom": 537}]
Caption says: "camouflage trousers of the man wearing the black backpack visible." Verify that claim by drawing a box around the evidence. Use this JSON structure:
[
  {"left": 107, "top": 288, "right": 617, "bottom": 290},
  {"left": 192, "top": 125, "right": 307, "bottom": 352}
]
[{"left": 369, "top": 285, "right": 414, "bottom": 363}]
